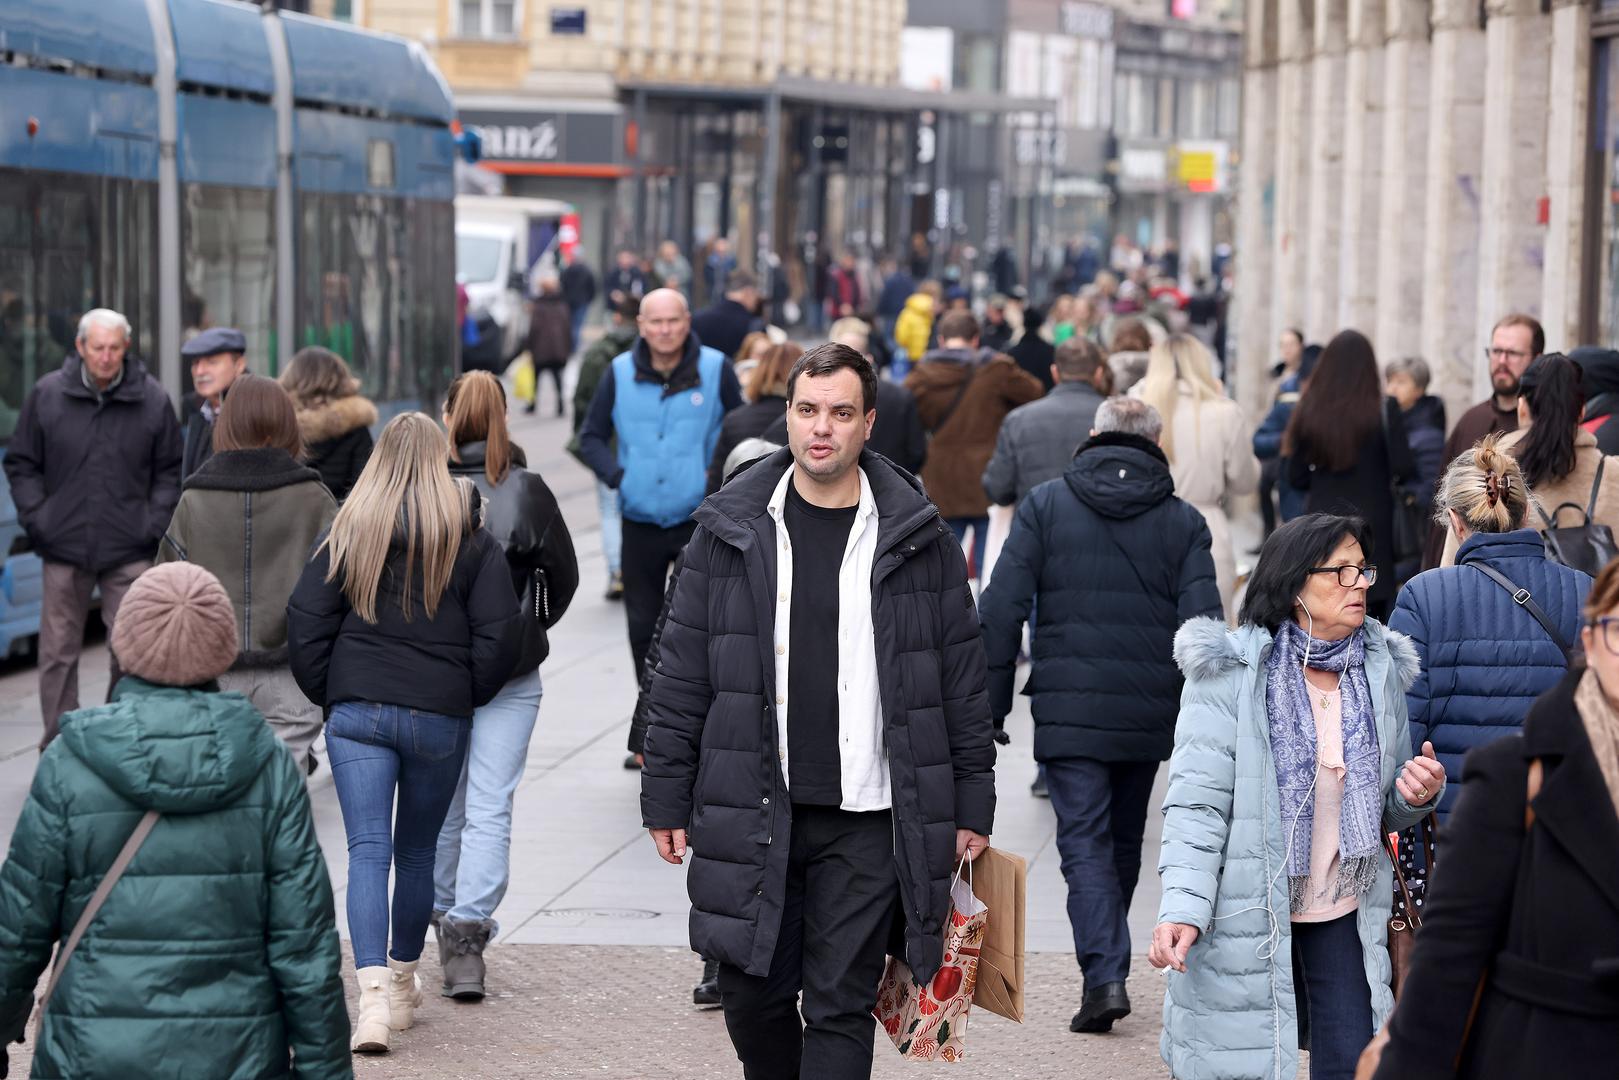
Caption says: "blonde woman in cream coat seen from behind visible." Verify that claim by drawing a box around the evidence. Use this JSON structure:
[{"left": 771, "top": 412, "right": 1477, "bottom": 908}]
[{"left": 1130, "top": 334, "right": 1260, "bottom": 620}]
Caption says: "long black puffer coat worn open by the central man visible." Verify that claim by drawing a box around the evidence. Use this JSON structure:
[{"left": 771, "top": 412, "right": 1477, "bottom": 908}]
[{"left": 641, "top": 450, "right": 996, "bottom": 981}]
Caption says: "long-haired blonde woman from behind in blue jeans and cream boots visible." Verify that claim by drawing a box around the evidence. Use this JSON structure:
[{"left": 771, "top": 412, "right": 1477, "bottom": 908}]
[{"left": 287, "top": 413, "right": 520, "bottom": 1052}]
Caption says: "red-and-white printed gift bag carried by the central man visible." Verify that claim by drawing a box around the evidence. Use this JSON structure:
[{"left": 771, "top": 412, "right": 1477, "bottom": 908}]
[{"left": 873, "top": 858, "right": 989, "bottom": 1061}]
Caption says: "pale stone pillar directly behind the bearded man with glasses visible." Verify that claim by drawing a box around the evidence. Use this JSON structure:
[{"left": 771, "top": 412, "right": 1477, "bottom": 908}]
[{"left": 1473, "top": 0, "right": 1551, "bottom": 397}]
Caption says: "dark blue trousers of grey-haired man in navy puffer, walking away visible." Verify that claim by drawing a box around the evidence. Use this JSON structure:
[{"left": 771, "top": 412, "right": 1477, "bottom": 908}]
[{"left": 1046, "top": 758, "right": 1158, "bottom": 989}]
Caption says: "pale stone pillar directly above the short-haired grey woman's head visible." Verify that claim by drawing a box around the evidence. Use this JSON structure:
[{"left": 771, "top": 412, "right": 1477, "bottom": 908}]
[{"left": 1371, "top": 0, "right": 1436, "bottom": 361}]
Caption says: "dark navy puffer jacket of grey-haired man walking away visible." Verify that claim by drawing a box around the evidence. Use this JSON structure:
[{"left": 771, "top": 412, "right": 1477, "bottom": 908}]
[{"left": 983, "top": 434, "right": 1224, "bottom": 761}]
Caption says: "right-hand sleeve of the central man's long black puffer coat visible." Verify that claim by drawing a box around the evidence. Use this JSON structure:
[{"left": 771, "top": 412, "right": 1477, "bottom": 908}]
[{"left": 934, "top": 538, "right": 996, "bottom": 836}]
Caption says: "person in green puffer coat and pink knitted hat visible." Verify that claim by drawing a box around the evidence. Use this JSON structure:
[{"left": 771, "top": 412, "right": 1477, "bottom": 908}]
[{"left": 0, "top": 562, "right": 353, "bottom": 1080}]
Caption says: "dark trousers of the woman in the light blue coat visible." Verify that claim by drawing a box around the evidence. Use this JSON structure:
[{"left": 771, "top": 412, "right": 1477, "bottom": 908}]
[{"left": 1294, "top": 912, "right": 1373, "bottom": 1080}]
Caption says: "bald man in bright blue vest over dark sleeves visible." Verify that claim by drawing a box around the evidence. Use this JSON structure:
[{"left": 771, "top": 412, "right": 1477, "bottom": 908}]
[{"left": 580, "top": 288, "right": 742, "bottom": 705}]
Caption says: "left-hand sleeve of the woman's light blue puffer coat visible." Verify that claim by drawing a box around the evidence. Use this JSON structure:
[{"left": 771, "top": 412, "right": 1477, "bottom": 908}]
[{"left": 1158, "top": 672, "right": 1239, "bottom": 933}]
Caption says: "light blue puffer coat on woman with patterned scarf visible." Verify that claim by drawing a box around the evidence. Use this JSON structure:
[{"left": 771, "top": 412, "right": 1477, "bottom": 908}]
[{"left": 1158, "top": 619, "right": 1428, "bottom": 1080}]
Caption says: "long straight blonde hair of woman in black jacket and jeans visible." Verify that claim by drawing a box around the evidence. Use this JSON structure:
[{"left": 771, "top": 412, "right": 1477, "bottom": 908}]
[{"left": 322, "top": 413, "right": 470, "bottom": 623}]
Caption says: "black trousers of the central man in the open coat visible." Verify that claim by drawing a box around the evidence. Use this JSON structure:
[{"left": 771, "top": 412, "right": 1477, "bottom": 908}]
[{"left": 719, "top": 806, "right": 900, "bottom": 1080}]
